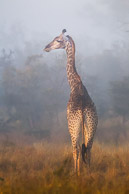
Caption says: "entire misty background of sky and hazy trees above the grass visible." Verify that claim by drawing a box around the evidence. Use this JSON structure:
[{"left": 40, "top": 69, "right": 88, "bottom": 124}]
[{"left": 0, "top": 0, "right": 129, "bottom": 144}]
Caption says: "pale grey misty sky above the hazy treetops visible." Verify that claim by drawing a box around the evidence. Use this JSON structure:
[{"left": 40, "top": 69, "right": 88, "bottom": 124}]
[{"left": 0, "top": 0, "right": 129, "bottom": 55}]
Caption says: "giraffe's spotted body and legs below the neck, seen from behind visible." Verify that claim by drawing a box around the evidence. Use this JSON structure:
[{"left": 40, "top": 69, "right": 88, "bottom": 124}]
[{"left": 67, "top": 83, "right": 98, "bottom": 172}]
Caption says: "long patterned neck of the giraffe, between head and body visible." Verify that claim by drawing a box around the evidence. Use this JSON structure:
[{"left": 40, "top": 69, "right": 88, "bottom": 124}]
[{"left": 66, "top": 40, "right": 81, "bottom": 91}]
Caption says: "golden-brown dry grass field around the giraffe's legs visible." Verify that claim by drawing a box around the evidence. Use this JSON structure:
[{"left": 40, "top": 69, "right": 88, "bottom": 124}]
[{"left": 0, "top": 139, "right": 129, "bottom": 194}]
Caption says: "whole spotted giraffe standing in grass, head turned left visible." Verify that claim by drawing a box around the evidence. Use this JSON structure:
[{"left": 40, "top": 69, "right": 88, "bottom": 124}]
[{"left": 44, "top": 29, "right": 98, "bottom": 175}]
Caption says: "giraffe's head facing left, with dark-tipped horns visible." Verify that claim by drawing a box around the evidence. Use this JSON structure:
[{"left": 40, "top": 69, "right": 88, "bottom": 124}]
[{"left": 44, "top": 29, "right": 68, "bottom": 52}]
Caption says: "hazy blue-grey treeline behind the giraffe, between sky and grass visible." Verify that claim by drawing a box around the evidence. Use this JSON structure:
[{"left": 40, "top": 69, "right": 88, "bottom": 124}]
[{"left": 0, "top": 42, "right": 129, "bottom": 146}]
